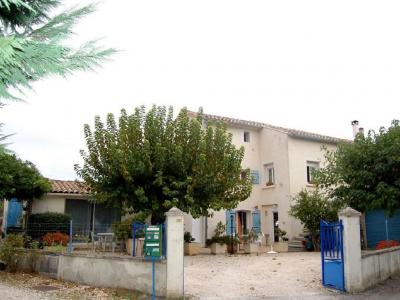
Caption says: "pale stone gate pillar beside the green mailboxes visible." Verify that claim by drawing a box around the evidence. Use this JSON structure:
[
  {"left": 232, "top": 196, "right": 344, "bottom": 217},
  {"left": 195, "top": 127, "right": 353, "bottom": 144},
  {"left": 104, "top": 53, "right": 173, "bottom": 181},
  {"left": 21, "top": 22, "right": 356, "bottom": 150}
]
[{"left": 165, "top": 207, "right": 184, "bottom": 299}]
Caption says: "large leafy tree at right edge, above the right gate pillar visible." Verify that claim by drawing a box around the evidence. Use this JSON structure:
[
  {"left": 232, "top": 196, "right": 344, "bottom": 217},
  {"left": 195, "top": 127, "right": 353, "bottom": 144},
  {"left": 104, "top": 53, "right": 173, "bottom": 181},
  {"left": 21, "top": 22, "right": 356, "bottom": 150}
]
[{"left": 315, "top": 120, "right": 400, "bottom": 215}]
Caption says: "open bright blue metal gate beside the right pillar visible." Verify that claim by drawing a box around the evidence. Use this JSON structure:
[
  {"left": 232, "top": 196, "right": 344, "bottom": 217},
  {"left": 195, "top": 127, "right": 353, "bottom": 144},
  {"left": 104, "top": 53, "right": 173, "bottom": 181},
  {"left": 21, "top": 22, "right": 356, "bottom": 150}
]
[{"left": 320, "top": 220, "right": 345, "bottom": 291}]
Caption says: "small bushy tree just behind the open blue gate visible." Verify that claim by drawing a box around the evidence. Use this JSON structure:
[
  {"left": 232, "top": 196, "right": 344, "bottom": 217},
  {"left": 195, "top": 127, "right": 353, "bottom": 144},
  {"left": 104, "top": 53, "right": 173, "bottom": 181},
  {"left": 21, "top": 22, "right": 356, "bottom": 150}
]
[{"left": 289, "top": 189, "right": 338, "bottom": 249}]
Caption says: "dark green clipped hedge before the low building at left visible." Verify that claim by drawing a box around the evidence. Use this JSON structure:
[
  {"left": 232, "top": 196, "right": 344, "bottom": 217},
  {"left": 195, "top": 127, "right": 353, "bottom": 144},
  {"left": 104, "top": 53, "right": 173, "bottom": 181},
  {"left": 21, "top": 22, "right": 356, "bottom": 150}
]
[{"left": 28, "top": 212, "right": 71, "bottom": 239}]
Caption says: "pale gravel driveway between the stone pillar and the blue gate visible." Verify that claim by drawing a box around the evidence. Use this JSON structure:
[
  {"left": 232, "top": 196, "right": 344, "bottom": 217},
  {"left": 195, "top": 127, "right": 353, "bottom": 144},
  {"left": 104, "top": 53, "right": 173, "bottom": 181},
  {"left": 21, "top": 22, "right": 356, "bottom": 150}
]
[{"left": 185, "top": 252, "right": 335, "bottom": 299}]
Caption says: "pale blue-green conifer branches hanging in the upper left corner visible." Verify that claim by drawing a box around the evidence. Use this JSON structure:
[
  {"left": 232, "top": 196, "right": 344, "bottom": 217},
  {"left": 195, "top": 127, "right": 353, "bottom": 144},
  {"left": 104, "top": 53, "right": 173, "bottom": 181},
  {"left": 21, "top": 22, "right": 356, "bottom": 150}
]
[{"left": 0, "top": 0, "right": 114, "bottom": 99}]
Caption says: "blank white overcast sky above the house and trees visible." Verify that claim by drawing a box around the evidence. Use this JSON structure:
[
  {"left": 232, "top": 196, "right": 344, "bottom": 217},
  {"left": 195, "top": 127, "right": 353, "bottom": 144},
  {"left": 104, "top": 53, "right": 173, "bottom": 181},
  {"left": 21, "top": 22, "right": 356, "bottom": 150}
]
[{"left": 0, "top": 0, "right": 400, "bottom": 180}]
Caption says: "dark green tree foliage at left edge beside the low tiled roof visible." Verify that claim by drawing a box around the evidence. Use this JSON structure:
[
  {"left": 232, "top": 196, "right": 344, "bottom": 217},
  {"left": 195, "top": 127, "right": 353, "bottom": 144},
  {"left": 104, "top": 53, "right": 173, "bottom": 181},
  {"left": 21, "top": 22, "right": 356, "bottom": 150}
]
[{"left": 0, "top": 153, "right": 50, "bottom": 200}]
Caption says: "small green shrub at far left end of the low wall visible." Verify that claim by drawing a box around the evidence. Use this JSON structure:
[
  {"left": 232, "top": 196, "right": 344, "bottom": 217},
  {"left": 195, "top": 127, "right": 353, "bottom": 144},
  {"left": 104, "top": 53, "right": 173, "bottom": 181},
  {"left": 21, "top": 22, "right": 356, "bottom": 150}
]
[{"left": 0, "top": 234, "right": 24, "bottom": 272}]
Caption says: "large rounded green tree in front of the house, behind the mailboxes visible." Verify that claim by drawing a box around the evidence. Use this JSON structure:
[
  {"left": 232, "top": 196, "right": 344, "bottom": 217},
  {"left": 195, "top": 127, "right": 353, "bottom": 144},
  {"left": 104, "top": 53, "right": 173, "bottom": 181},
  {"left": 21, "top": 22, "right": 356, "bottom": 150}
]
[{"left": 75, "top": 106, "right": 252, "bottom": 223}]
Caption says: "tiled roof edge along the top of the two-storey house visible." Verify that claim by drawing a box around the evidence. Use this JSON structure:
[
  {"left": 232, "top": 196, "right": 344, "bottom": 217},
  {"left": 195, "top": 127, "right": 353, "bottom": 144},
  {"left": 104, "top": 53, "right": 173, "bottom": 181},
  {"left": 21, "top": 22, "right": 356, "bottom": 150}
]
[{"left": 188, "top": 111, "right": 351, "bottom": 144}]
